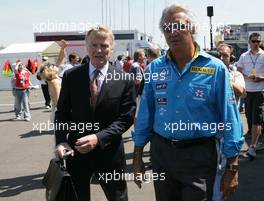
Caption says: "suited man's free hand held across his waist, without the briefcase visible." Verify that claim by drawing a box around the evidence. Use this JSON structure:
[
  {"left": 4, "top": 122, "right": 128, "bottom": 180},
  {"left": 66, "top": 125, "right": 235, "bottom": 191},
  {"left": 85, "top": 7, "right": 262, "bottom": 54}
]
[{"left": 75, "top": 134, "right": 98, "bottom": 154}]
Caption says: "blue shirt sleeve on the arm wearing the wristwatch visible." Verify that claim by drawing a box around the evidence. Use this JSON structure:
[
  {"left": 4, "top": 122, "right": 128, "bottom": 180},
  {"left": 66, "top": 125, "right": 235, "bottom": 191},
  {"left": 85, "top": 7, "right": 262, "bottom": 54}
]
[{"left": 215, "top": 65, "right": 244, "bottom": 158}]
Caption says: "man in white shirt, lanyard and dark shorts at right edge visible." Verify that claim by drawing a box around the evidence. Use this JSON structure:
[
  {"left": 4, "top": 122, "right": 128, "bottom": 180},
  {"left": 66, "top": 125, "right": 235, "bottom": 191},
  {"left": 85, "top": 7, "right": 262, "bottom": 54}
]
[{"left": 237, "top": 33, "right": 264, "bottom": 159}]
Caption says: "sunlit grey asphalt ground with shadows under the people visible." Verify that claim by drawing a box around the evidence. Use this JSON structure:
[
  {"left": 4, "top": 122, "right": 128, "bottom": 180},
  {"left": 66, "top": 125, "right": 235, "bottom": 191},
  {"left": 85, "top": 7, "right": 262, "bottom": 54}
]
[{"left": 0, "top": 90, "right": 264, "bottom": 201}]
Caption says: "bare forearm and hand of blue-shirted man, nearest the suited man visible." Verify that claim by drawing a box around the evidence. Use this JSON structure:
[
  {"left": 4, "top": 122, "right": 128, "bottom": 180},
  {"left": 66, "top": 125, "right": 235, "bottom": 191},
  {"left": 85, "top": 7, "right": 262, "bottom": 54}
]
[{"left": 133, "top": 147, "right": 145, "bottom": 188}]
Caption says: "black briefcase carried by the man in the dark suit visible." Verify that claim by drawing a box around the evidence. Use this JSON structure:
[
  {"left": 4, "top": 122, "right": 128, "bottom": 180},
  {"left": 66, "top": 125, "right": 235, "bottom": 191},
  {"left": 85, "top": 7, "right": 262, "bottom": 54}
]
[{"left": 42, "top": 158, "right": 78, "bottom": 201}]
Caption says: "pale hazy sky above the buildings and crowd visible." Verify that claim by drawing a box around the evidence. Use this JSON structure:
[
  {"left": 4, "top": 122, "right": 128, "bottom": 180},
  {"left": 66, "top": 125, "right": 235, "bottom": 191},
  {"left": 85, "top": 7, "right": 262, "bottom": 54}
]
[{"left": 0, "top": 0, "right": 264, "bottom": 46}]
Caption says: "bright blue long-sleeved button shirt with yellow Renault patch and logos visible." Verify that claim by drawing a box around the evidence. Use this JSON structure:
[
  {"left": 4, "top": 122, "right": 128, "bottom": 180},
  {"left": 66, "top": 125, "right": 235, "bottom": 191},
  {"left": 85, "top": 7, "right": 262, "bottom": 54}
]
[{"left": 132, "top": 46, "right": 244, "bottom": 157}]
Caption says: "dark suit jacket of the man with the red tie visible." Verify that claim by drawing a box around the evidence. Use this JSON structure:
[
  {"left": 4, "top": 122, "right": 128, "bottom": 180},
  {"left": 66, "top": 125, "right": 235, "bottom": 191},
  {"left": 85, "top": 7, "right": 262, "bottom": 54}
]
[{"left": 55, "top": 64, "right": 136, "bottom": 168}]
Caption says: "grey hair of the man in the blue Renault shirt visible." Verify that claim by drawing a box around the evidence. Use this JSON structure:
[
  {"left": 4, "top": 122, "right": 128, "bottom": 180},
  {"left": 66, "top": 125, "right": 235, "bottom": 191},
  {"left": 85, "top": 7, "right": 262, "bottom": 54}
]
[{"left": 159, "top": 4, "right": 196, "bottom": 35}]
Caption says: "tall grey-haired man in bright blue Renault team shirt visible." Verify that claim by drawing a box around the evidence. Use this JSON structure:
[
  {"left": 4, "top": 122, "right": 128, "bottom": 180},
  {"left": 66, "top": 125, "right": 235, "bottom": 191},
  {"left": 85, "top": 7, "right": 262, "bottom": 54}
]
[{"left": 133, "top": 5, "right": 244, "bottom": 201}]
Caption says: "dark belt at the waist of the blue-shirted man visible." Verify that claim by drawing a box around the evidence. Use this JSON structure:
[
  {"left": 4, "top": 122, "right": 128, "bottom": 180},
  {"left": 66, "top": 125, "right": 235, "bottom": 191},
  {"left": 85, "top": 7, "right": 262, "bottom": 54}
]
[{"left": 154, "top": 133, "right": 215, "bottom": 148}]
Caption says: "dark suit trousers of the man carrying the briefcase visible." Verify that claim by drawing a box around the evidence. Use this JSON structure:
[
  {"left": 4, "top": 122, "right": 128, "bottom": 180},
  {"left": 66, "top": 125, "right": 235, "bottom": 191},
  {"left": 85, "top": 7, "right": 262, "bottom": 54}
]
[{"left": 67, "top": 158, "right": 128, "bottom": 201}]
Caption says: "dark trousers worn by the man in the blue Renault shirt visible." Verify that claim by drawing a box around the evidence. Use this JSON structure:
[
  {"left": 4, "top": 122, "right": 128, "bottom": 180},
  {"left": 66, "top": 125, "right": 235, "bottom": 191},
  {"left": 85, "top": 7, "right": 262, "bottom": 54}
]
[{"left": 151, "top": 135, "right": 217, "bottom": 201}]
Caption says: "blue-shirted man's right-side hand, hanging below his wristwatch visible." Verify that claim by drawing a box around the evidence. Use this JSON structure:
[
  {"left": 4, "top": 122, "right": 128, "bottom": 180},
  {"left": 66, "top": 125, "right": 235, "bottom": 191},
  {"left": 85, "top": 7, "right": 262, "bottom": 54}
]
[{"left": 220, "top": 169, "right": 238, "bottom": 200}]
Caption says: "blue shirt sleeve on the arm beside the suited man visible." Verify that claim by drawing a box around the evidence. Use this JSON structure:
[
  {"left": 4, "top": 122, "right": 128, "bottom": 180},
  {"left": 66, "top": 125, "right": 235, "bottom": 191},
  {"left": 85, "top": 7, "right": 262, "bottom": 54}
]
[{"left": 132, "top": 65, "right": 155, "bottom": 147}]
